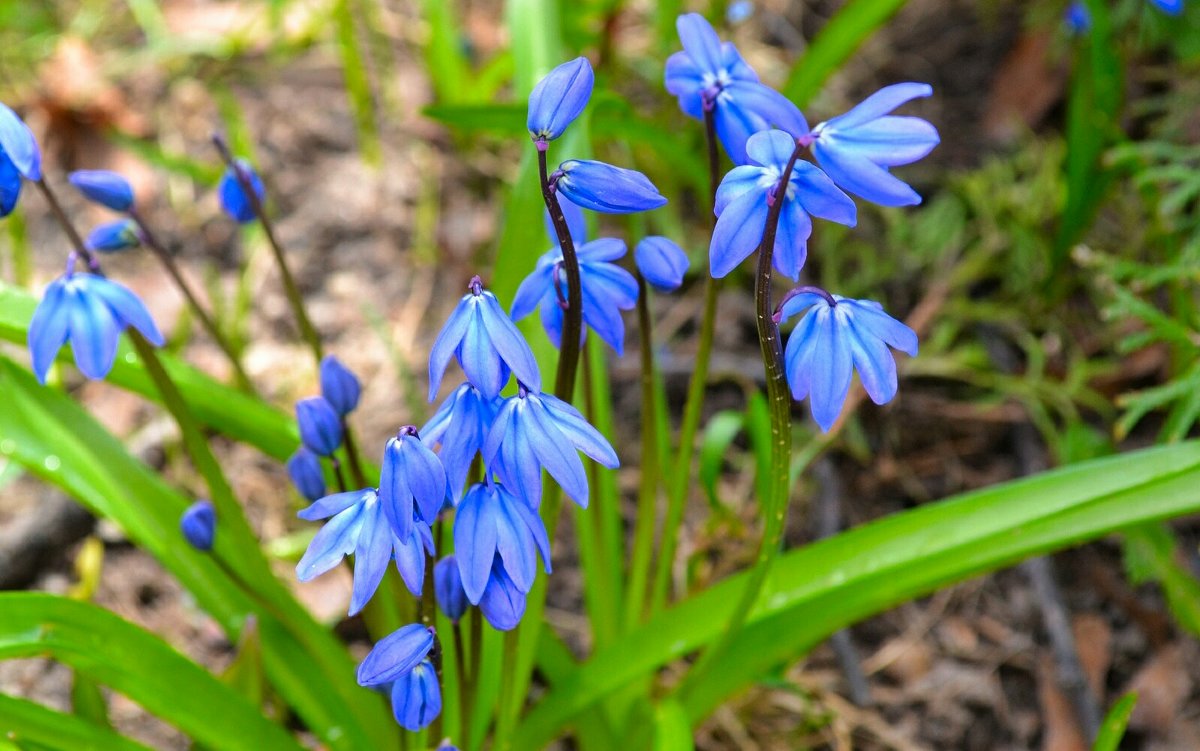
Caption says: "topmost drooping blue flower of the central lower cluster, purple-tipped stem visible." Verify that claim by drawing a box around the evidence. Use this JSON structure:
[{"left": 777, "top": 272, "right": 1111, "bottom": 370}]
[{"left": 430, "top": 276, "right": 541, "bottom": 402}]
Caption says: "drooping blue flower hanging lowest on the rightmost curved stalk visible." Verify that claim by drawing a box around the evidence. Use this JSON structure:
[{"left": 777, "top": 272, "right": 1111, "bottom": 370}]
[{"left": 775, "top": 287, "right": 917, "bottom": 431}]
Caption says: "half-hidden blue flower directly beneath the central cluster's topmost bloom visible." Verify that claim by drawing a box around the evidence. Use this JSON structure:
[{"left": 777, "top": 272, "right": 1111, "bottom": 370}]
[{"left": 420, "top": 383, "right": 500, "bottom": 498}]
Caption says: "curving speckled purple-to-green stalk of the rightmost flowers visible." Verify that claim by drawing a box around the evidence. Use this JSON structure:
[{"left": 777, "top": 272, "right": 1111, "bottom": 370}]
[{"left": 680, "top": 137, "right": 805, "bottom": 696}]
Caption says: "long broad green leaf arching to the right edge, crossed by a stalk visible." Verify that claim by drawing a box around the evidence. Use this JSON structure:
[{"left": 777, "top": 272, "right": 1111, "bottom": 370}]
[{"left": 515, "top": 441, "right": 1200, "bottom": 749}]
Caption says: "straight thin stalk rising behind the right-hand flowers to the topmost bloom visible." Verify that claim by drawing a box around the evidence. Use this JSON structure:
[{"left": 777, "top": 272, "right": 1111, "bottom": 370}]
[{"left": 650, "top": 109, "right": 721, "bottom": 614}]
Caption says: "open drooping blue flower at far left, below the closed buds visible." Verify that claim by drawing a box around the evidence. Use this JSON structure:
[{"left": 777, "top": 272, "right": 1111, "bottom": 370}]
[{"left": 29, "top": 269, "right": 163, "bottom": 383}]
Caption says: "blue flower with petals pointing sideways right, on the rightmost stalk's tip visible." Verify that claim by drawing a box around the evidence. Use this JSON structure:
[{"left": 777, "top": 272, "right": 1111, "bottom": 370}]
[{"left": 811, "top": 83, "right": 941, "bottom": 206}]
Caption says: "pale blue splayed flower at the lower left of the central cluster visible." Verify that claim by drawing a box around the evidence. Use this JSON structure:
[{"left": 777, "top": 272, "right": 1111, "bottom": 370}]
[{"left": 296, "top": 488, "right": 433, "bottom": 615}]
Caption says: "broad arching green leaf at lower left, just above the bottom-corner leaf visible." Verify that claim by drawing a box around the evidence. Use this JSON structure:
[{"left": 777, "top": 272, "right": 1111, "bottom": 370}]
[{"left": 0, "top": 593, "right": 301, "bottom": 751}]
